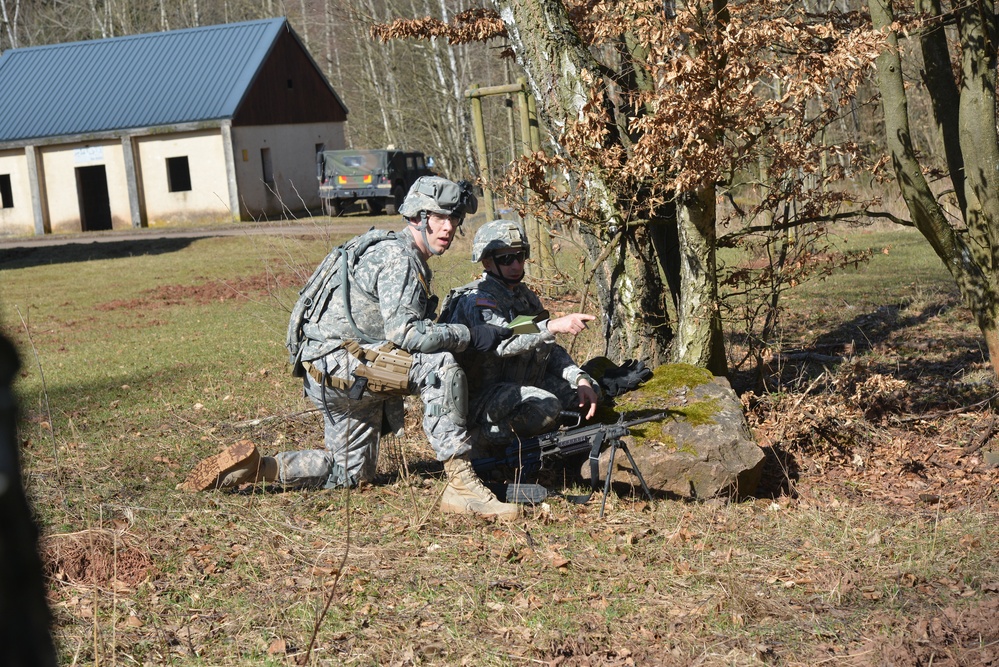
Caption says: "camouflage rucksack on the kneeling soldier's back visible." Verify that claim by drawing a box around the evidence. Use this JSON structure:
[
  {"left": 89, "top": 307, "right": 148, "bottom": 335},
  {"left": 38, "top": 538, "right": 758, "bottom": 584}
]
[{"left": 285, "top": 229, "right": 396, "bottom": 377}]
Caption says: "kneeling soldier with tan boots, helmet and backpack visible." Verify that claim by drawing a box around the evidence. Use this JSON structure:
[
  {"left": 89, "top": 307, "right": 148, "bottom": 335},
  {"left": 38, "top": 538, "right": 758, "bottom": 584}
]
[{"left": 182, "top": 176, "right": 520, "bottom": 519}]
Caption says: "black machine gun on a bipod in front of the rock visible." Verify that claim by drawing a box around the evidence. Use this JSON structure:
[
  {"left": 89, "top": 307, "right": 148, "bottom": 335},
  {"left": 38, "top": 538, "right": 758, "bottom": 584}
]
[{"left": 472, "top": 412, "right": 667, "bottom": 518}]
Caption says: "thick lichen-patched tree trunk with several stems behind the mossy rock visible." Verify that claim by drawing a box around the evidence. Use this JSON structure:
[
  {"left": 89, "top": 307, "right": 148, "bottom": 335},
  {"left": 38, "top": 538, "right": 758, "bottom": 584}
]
[{"left": 493, "top": 0, "right": 726, "bottom": 374}]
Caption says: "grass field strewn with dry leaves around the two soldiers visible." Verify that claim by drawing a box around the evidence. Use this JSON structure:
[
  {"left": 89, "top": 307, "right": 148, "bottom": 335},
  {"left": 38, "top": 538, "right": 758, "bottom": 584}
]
[{"left": 0, "top": 220, "right": 999, "bottom": 666}]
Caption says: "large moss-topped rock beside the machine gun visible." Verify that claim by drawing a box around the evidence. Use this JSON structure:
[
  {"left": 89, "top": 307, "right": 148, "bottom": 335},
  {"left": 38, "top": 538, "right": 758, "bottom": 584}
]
[{"left": 581, "top": 364, "right": 764, "bottom": 499}]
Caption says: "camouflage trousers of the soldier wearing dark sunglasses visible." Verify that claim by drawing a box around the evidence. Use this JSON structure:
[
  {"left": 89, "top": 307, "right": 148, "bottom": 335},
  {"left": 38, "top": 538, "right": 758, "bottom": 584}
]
[{"left": 469, "top": 375, "right": 579, "bottom": 458}]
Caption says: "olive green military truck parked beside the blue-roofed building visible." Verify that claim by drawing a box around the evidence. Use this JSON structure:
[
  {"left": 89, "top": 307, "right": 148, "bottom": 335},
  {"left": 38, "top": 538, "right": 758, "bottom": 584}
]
[{"left": 316, "top": 149, "right": 433, "bottom": 215}]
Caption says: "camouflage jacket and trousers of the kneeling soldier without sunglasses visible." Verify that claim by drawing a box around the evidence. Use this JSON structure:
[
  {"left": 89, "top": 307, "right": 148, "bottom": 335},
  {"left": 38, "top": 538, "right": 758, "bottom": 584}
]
[{"left": 275, "top": 230, "right": 470, "bottom": 488}]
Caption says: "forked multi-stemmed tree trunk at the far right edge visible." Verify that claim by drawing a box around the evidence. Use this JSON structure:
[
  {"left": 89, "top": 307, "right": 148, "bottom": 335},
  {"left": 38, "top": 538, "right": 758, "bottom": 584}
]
[{"left": 869, "top": 0, "right": 999, "bottom": 376}]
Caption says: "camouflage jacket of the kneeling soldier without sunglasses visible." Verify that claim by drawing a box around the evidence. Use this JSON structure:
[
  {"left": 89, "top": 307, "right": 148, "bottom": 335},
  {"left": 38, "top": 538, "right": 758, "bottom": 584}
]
[{"left": 302, "top": 229, "right": 469, "bottom": 360}]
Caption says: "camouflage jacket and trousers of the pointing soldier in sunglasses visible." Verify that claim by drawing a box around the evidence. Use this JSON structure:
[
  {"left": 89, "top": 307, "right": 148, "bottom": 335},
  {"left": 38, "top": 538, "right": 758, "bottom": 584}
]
[{"left": 443, "top": 273, "right": 596, "bottom": 456}]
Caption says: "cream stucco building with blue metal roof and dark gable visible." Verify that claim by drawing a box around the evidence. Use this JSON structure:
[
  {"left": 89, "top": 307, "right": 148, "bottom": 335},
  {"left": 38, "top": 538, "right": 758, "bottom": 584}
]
[{"left": 0, "top": 18, "right": 347, "bottom": 235}]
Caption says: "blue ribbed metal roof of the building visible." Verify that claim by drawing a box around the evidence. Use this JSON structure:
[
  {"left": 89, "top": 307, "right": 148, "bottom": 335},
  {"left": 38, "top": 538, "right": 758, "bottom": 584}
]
[{"left": 0, "top": 18, "right": 290, "bottom": 143}]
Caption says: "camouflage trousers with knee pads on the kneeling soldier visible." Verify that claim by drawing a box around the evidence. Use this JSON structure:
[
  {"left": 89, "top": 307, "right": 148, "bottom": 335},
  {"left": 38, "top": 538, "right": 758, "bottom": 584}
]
[{"left": 275, "top": 346, "right": 471, "bottom": 488}]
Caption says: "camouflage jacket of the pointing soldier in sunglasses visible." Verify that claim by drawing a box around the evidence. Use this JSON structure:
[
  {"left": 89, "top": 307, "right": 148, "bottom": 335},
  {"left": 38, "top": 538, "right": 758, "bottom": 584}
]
[{"left": 441, "top": 273, "right": 589, "bottom": 400}]
